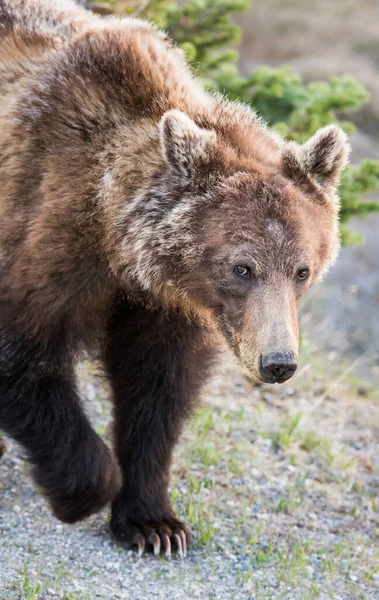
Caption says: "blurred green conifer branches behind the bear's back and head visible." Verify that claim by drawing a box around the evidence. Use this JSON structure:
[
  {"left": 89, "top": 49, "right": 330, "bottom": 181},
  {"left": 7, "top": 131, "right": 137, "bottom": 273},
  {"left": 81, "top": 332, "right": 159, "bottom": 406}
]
[{"left": 94, "top": 0, "right": 379, "bottom": 245}]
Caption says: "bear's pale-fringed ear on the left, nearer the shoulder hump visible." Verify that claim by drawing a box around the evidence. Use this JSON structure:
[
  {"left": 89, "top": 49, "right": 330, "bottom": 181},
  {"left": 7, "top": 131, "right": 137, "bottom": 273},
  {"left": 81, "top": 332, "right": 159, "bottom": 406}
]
[{"left": 160, "top": 110, "right": 216, "bottom": 180}]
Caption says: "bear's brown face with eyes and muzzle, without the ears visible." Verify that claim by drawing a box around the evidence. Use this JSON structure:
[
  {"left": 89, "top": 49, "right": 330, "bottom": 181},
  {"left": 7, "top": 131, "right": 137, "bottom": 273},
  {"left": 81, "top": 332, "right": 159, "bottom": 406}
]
[{"left": 183, "top": 173, "right": 339, "bottom": 383}]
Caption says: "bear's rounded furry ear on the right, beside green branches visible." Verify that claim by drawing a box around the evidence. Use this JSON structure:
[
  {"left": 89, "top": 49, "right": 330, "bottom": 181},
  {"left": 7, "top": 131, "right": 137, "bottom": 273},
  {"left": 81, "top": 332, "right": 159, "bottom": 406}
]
[{"left": 283, "top": 125, "right": 350, "bottom": 191}]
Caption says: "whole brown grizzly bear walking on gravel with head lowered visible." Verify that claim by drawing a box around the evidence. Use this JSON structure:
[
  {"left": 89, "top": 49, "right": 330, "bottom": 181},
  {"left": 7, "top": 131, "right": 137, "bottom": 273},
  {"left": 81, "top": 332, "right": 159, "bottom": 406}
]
[{"left": 0, "top": 0, "right": 348, "bottom": 555}]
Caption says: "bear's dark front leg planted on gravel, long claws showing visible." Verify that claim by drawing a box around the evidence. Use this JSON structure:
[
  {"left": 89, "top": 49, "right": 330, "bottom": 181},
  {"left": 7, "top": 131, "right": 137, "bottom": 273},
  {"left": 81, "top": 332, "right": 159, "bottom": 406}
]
[{"left": 104, "top": 302, "right": 212, "bottom": 557}]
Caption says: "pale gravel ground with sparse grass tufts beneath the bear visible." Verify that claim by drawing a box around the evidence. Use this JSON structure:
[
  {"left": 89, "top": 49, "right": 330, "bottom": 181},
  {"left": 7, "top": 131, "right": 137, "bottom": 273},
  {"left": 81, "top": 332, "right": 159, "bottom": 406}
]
[{"left": 0, "top": 347, "right": 379, "bottom": 600}]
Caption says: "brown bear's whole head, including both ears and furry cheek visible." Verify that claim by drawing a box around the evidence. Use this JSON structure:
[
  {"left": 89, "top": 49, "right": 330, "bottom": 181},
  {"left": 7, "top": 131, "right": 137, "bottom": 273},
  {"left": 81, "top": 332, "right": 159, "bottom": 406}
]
[{"left": 120, "top": 110, "right": 348, "bottom": 383}]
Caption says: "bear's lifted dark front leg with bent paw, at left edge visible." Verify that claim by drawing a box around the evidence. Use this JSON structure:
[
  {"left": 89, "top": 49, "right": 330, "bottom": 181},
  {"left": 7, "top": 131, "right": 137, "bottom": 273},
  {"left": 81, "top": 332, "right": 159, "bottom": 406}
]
[{"left": 0, "top": 332, "right": 120, "bottom": 523}]
